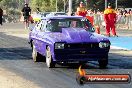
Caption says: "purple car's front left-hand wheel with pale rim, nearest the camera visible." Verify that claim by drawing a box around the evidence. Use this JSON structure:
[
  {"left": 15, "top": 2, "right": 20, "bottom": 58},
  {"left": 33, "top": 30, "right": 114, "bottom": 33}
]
[{"left": 46, "top": 46, "right": 55, "bottom": 68}]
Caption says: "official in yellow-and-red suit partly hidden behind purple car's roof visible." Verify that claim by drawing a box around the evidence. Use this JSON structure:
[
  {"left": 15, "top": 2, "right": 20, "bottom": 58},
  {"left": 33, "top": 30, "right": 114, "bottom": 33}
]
[{"left": 76, "top": 2, "right": 87, "bottom": 17}]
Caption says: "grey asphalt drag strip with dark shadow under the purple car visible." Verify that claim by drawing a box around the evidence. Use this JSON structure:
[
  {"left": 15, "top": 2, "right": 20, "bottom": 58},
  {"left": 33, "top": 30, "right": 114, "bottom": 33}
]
[{"left": 0, "top": 23, "right": 132, "bottom": 88}]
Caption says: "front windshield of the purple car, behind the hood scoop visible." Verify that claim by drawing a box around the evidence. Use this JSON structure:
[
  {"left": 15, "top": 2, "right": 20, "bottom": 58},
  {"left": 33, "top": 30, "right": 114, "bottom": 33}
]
[{"left": 47, "top": 18, "right": 94, "bottom": 32}]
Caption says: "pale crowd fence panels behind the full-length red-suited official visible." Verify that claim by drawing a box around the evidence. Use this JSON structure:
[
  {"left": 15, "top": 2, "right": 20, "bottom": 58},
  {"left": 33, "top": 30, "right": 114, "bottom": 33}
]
[{"left": 87, "top": 14, "right": 132, "bottom": 29}]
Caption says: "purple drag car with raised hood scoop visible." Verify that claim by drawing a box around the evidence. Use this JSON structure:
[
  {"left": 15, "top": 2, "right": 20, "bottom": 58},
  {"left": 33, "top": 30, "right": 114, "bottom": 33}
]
[{"left": 29, "top": 16, "right": 110, "bottom": 68}]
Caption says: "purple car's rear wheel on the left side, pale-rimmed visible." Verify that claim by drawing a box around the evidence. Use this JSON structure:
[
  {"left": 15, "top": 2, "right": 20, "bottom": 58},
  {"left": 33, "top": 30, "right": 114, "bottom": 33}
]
[{"left": 32, "top": 45, "right": 42, "bottom": 62}]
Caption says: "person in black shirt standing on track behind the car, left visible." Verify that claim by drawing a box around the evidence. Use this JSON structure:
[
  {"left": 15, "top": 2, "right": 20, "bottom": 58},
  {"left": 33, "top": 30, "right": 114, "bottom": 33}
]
[{"left": 22, "top": 3, "right": 31, "bottom": 29}]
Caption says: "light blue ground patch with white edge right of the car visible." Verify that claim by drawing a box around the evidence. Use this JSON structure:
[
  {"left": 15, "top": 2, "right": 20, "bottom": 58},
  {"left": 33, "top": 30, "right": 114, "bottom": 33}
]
[{"left": 109, "top": 36, "right": 132, "bottom": 50}]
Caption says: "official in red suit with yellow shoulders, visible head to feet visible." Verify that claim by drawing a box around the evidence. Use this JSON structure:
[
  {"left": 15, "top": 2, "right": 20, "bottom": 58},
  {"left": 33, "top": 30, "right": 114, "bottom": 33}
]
[{"left": 104, "top": 3, "right": 117, "bottom": 37}]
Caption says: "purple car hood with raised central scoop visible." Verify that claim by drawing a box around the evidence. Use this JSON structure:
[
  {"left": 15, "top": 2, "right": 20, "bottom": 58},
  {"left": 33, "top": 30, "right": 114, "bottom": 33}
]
[{"left": 48, "top": 28, "right": 108, "bottom": 43}]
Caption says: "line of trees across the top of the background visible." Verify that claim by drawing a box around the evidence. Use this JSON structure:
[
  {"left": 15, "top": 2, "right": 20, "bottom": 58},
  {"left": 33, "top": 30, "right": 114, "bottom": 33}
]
[{"left": 0, "top": 0, "right": 132, "bottom": 12}]
